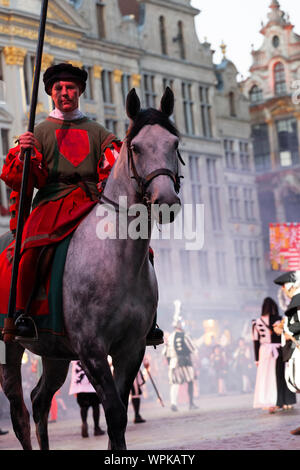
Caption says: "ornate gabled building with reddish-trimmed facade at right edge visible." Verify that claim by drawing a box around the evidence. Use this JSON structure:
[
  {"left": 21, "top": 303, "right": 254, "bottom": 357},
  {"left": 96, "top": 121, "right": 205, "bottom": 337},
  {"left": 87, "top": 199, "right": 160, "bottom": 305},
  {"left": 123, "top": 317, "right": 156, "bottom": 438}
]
[{"left": 243, "top": 0, "right": 300, "bottom": 294}]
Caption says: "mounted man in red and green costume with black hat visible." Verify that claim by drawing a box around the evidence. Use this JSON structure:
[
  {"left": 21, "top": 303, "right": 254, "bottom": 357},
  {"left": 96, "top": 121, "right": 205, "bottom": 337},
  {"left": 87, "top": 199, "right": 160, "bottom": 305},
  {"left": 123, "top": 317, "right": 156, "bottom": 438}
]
[{"left": 0, "top": 63, "right": 163, "bottom": 344}]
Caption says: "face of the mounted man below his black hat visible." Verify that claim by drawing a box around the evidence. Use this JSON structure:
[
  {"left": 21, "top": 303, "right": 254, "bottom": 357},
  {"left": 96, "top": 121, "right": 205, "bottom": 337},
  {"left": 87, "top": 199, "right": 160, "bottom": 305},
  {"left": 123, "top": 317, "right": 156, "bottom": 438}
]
[{"left": 51, "top": 81, "right": 80, "bottom": 113}]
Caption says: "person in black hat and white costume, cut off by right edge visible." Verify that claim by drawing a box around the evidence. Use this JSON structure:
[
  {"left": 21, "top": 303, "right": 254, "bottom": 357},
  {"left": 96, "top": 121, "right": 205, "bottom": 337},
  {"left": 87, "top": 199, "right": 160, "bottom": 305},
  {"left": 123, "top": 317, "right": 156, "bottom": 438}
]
[{"left": 274, "top": 271, "right": 300, "bottom": 435}]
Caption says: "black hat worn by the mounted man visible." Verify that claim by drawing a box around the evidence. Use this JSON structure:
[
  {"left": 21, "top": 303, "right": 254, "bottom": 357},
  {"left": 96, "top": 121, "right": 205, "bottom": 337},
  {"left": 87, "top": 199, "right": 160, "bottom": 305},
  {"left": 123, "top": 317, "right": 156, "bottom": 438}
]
[{"left": 43, "top": 63, "right": 88, "bottom": 95}]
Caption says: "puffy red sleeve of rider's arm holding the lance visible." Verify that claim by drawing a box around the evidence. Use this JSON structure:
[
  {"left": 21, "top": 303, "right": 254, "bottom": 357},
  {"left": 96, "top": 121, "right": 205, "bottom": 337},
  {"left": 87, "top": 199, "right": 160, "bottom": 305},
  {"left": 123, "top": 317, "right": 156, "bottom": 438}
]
[{"left": 0, "top": 145, "right": 48, "bottom": 194}]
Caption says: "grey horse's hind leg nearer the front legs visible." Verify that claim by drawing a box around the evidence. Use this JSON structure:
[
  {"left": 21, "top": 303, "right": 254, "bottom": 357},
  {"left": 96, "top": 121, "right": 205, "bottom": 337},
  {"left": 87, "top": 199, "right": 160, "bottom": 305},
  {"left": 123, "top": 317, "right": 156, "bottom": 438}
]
[{"left": 31, "top": 357, "right": 70, "bottom": 450}]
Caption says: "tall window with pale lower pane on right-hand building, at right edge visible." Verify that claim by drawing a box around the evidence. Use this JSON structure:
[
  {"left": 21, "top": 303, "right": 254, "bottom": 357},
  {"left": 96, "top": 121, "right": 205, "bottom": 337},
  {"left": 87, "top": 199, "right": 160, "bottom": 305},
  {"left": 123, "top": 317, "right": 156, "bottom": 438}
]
[{"left": 276, "top": 118, "right": 299, "bottom": 167}]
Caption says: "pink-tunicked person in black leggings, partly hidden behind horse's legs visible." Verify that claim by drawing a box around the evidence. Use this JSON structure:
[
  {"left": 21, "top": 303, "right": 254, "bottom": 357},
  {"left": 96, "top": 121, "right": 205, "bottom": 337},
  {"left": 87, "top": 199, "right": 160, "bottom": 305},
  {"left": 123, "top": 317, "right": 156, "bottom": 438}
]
[{"left": 69, "top": 361, "right": 105, "bottom": 437}]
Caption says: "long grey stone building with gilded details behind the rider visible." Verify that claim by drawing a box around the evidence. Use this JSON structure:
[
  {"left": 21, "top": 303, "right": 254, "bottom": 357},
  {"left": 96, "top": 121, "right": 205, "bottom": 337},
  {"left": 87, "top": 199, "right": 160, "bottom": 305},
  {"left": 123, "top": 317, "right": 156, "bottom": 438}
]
[{"left": 0, "top": 0, "right": 266, "bottom": 332}]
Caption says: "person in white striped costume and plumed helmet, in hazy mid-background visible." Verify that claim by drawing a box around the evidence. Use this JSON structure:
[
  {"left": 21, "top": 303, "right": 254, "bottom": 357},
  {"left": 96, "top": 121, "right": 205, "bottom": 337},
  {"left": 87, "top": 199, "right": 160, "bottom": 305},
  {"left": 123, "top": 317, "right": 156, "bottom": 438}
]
[{"left": 163, "top": 301, "right": 198, "bottom": 411}]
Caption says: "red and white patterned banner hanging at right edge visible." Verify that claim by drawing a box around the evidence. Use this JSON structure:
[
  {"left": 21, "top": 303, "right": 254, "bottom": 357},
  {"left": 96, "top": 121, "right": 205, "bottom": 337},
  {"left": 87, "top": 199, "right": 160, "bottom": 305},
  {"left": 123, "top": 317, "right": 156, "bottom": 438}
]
[{"left": 270, "top": 223, "right": 300, "bottom": 271}]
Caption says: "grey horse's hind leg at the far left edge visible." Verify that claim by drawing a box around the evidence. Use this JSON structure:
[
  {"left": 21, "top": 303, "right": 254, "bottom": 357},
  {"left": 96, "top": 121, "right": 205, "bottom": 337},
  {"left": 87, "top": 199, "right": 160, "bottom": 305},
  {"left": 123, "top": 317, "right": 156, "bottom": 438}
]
[{"left": 0, "top": 343, "right": 32, "bottom": 450}]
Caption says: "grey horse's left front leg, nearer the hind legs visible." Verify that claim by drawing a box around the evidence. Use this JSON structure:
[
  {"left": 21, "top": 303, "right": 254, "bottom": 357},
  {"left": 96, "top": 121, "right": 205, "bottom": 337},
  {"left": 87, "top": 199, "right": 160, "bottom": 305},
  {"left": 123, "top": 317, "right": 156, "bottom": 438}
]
[{"left": 79, "top": 348, "right": 127, "bottom": 450}]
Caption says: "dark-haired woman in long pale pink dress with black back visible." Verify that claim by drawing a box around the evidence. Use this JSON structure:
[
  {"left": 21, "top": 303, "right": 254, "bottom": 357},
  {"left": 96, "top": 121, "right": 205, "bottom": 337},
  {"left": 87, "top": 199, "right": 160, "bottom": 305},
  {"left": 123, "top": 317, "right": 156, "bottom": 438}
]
[{"left": 252, "top": 297, "right": 296, "bottom": 413}]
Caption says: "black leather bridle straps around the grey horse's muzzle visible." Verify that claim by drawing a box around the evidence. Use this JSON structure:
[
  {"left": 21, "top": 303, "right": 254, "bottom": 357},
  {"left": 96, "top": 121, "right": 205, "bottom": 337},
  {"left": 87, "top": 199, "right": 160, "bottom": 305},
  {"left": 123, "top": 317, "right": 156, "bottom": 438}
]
[{"left": 127, "top": 138, "right": 185, "bottom": 200}]
